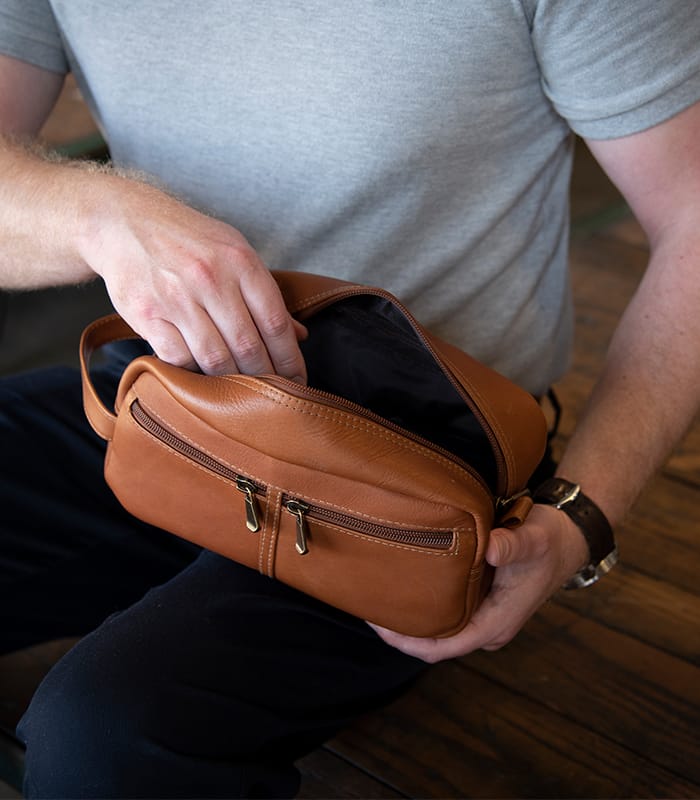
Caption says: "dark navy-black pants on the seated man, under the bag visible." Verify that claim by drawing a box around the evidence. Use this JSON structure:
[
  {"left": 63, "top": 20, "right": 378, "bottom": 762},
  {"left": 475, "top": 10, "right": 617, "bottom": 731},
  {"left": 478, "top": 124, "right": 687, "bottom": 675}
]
[{"left": 0, "top": 361, "right": 423, "bottom": 798}]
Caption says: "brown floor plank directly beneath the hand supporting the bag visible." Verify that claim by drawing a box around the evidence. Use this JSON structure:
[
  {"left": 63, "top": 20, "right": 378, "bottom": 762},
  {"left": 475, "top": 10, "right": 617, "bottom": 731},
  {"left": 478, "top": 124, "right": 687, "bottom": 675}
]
[{"left": 465, "top": 600, "right": 700, "bottom": 790}]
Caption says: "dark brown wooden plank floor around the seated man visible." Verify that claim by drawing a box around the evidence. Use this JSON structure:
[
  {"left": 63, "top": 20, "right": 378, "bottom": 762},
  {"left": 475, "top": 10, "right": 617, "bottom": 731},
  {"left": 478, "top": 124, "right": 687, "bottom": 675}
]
[{"left": 0, "top": 78, "right": 700, "bottom": 798}]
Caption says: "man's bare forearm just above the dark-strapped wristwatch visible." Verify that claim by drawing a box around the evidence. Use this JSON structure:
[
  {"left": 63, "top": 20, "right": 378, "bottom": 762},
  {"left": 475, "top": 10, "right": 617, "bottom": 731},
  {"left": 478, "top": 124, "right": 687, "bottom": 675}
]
[{"left": 559, "top": 227, "right": 700, "bottom": 526}]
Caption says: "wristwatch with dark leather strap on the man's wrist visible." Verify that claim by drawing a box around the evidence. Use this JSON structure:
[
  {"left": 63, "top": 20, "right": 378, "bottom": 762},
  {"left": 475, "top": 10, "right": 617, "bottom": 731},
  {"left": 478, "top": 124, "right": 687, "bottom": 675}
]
[{"left": 532, "top": 478, "right": 617, "bottom": 589}]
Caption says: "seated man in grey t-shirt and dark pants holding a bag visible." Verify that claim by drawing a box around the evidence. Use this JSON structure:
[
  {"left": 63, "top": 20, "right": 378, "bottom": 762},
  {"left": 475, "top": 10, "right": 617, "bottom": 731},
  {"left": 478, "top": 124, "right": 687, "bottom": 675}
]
[{"left": 0, "top": 0, "right": 700, "bottom": 797}]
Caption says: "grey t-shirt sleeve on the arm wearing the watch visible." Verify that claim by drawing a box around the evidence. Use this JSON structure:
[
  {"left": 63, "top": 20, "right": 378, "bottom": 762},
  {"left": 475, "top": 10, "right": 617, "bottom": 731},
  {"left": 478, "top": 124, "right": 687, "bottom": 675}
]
[{"left": 532, "top": 0, "right": 700, "bottom": 139}]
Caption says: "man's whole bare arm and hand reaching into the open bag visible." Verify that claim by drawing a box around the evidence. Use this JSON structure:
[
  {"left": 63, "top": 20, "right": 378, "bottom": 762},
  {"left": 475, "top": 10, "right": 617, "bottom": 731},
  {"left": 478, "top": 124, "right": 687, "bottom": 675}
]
[{"left": 0, "top": 55, "right": 306, "bottom": 381}]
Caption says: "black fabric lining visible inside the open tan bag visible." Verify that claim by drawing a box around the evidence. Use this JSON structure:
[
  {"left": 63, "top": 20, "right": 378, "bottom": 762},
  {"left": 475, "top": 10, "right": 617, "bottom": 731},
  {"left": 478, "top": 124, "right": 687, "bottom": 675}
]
[{"left": 301, "top": 295, "right": 497, "bottom": 493}]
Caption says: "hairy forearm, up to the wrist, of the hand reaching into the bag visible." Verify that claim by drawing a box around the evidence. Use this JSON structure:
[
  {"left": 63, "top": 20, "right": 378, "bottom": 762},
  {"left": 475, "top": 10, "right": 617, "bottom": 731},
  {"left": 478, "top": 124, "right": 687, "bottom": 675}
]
[{"left": 0, "top": 138, "right": 106, "bottom": 289}]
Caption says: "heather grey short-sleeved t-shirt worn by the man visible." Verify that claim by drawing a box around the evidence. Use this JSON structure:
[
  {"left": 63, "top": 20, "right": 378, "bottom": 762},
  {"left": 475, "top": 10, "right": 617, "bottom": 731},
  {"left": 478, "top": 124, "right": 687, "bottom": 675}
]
[{"left": 0, "top": 0, "right": 700, "bottom": 393}]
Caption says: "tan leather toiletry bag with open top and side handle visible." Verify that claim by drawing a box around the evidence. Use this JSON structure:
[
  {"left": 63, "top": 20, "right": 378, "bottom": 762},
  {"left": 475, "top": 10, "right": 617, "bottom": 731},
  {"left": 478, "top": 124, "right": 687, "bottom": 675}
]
[{"left": 81, "top": 272, "right": 546, "bottom": 636}]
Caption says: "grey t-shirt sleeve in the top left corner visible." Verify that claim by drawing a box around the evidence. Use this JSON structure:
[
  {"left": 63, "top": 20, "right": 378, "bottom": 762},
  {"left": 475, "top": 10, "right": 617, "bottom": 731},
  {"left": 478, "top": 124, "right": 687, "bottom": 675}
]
[{"left": 0, "top": 0, "right": 69, "bottom": 73}]
